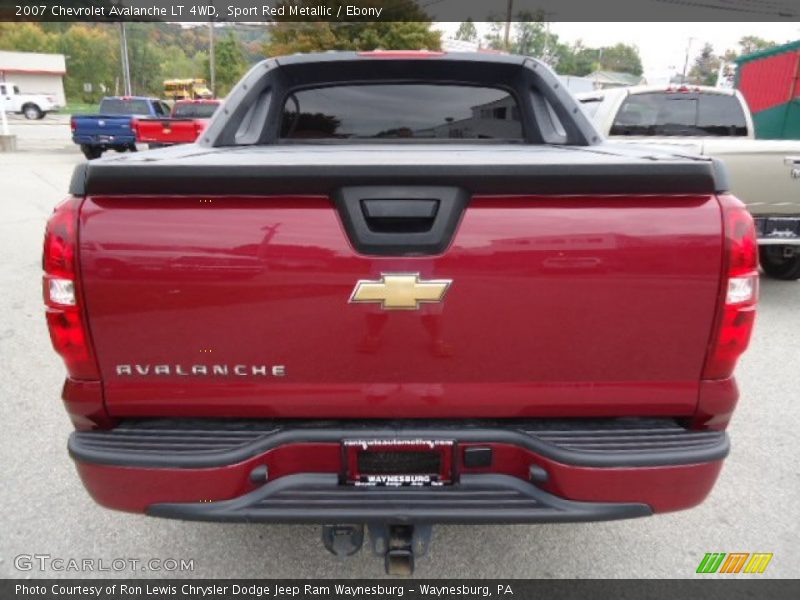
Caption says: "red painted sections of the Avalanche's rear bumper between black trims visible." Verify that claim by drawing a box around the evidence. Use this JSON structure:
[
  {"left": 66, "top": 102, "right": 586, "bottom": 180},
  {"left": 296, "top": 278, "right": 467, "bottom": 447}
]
[{"left": 77, "top": 444, "right": 722, "bottom": 512}]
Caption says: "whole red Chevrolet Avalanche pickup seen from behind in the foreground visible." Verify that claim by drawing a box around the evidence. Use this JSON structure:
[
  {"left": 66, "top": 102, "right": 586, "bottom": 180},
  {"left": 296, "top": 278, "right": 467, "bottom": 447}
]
[{"left": 44, "top": 51, "right": 758, "bottom": 573}]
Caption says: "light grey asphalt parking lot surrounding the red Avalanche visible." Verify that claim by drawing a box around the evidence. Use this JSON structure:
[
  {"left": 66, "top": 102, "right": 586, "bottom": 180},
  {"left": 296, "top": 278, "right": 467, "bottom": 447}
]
[{"left": 0, "top": 117, "right": 800, "bottom": 578}]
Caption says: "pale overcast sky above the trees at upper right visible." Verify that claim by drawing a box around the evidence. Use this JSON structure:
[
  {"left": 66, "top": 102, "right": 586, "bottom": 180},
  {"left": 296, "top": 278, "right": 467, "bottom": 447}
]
[{"left": 437, "top": 23, "right": 800, "bottom": 78}]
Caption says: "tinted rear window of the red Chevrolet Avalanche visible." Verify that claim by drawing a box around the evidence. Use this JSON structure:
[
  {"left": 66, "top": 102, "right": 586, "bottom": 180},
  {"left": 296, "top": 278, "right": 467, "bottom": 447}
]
[{"left": 281, "top": 84, "right": 523, "bottom": 140}]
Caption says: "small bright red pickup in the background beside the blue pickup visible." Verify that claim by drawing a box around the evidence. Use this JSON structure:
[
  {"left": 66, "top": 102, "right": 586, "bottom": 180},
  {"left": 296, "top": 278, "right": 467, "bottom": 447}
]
[{"left": 132, "top": 100, "right": 221, "bottom": 148}]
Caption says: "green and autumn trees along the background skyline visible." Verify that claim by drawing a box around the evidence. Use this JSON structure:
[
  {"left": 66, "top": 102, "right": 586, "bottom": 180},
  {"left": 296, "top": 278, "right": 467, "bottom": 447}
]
[{"left": 0, "top": 18, "right": 775, "bottom": 103}]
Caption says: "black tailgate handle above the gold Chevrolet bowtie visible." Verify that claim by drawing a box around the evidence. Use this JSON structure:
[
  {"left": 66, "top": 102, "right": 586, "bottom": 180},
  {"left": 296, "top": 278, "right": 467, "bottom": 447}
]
[{"left": 361, "top": 198, "right": 439, "bottom": 233}]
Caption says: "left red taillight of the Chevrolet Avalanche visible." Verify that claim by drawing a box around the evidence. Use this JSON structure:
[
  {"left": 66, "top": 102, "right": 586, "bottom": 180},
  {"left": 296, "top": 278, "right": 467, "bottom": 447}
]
[{"left": 42, "top": 197, "right": 100, "bottom": 379}]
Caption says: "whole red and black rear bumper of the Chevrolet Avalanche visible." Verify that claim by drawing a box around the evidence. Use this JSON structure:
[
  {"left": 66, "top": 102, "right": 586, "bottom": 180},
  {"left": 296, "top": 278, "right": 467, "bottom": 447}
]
[{"left": 69, "top": 419, "right": 729, "bottom": 523}]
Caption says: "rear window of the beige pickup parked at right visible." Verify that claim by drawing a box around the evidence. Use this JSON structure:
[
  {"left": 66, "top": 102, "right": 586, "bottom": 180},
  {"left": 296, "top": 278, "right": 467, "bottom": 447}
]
[{"left": 611, "top": 92, "right": 747, "bottom": 136}]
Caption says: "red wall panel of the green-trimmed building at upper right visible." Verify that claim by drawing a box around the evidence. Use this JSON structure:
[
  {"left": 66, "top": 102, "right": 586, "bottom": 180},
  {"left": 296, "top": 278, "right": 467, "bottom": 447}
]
[{"left": 737, "top": 50, "right": 800, "bottom": 113}]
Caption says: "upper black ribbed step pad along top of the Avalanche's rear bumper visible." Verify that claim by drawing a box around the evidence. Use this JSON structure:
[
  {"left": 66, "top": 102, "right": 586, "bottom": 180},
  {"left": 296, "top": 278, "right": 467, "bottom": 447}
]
[{"left": 69, "top": 419, "right": 730, "bottom": 469}]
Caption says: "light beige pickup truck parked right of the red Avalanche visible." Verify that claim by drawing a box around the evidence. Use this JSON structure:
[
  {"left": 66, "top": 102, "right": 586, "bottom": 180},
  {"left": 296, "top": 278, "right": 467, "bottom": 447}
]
[{"left": 578, "top": 86, "right": 800, "bottom": 279}]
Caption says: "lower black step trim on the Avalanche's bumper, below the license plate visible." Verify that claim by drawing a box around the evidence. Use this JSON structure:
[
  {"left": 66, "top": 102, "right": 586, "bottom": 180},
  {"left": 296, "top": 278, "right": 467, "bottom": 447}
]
[{"left": 147, "top": 473, "right": 652, "bottom": 524}]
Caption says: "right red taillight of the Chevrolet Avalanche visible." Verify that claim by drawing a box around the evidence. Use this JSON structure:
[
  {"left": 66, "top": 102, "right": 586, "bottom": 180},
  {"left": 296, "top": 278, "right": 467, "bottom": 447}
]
[{"left": 703, "top": 194, "right": 758, "bottom": 379}]
